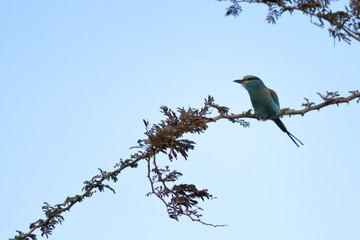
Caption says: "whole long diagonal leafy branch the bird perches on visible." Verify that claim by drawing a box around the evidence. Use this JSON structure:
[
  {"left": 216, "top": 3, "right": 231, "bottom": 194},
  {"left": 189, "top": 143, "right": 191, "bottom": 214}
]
[{"left": 10, "top": 90, "right": 360, "bottom": 240}]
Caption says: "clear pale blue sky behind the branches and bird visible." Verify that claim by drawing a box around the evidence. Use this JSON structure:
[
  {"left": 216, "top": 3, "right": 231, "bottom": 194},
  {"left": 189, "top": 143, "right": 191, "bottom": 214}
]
[{"left": 0, "top": 0, "right": 360, "bottom": 240}]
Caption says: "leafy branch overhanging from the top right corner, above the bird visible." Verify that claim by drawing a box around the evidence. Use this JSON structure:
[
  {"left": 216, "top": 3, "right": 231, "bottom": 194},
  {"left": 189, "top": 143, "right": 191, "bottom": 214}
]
[{"left": 216, "top": 0, "right": 360, "bottom": 43}]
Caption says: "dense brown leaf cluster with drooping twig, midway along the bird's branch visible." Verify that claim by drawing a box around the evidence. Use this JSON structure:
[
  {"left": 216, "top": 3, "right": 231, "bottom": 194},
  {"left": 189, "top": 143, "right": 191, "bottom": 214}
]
[{"left": 137, "top": 96, "right": 228, "bottom": 226}]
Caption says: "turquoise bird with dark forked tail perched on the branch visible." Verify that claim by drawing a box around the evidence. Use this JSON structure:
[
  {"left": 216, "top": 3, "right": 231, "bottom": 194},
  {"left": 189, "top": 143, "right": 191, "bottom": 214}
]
[{"left": 234, "top": 75, "right": 304, "bottom": 147}]
